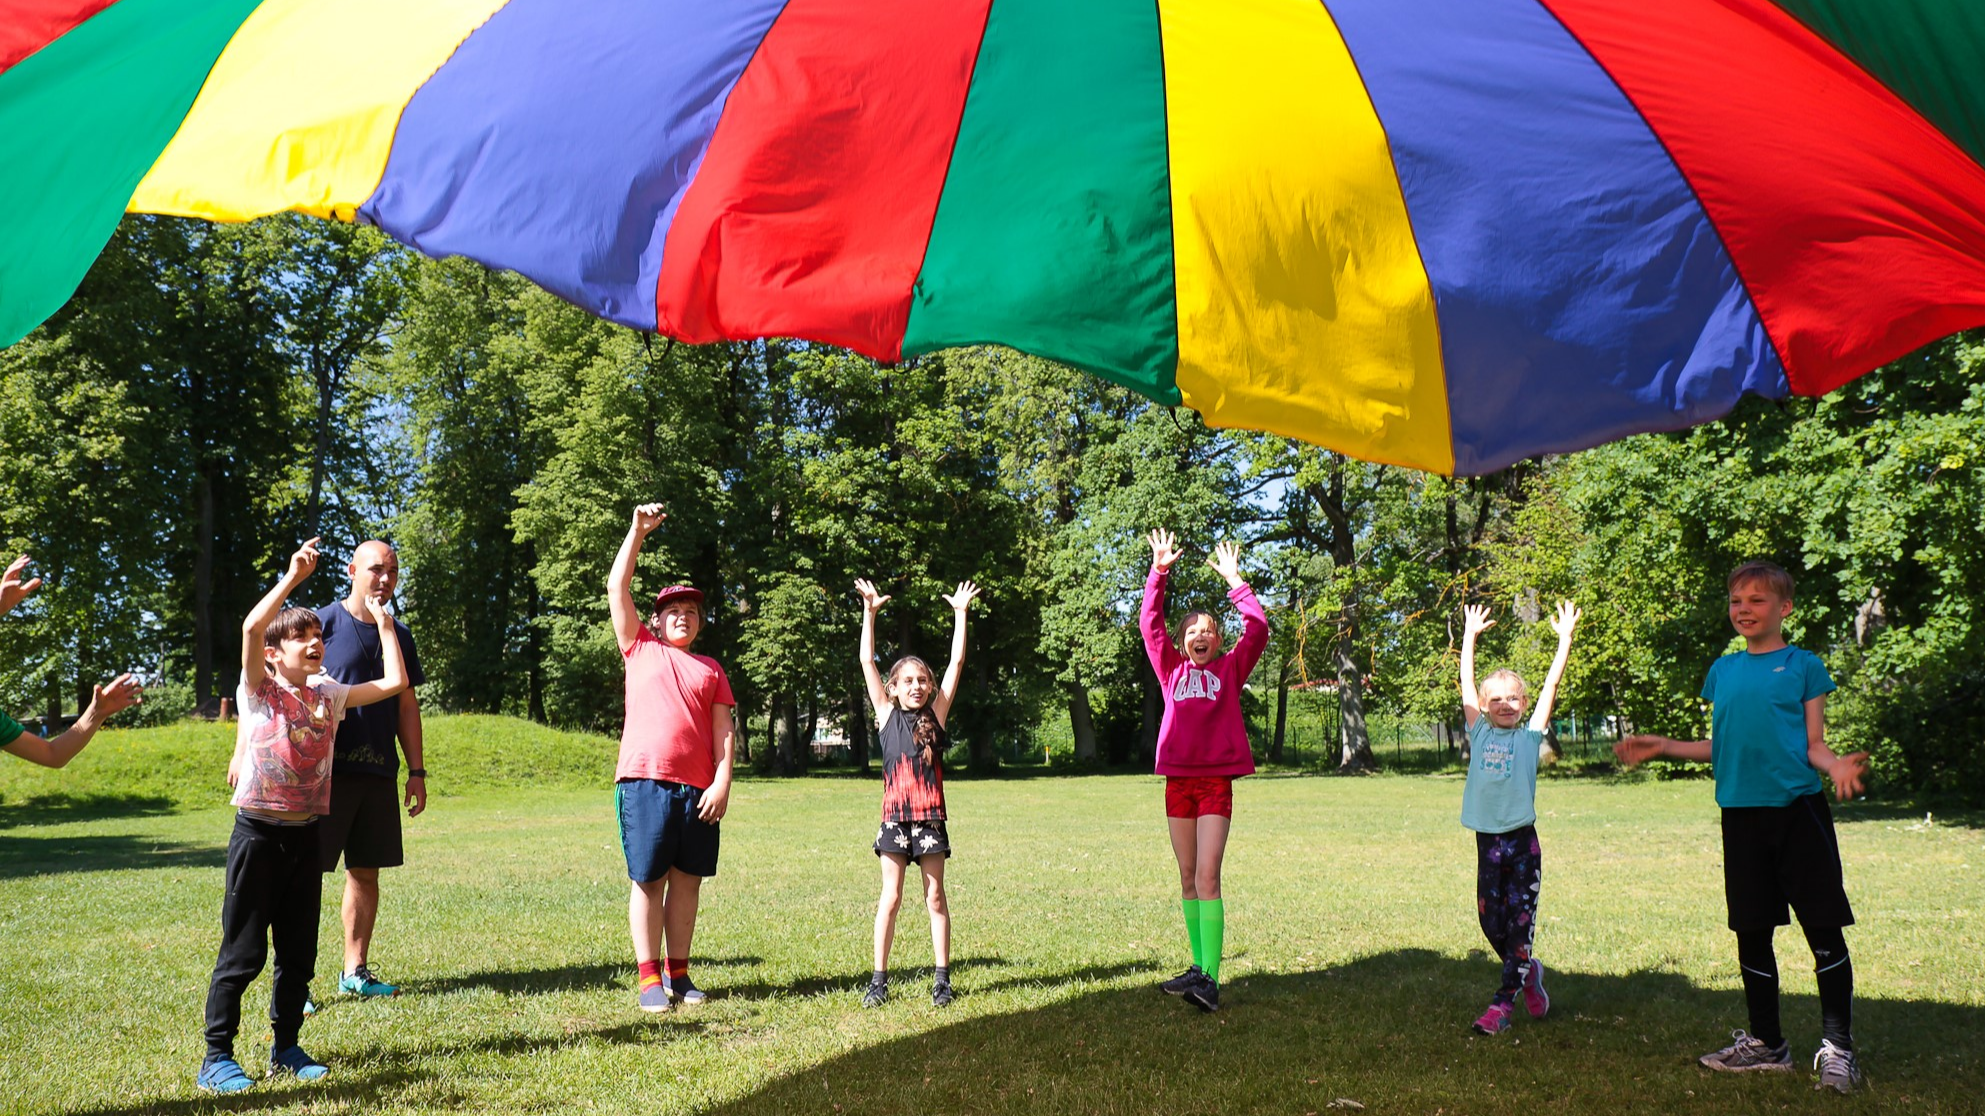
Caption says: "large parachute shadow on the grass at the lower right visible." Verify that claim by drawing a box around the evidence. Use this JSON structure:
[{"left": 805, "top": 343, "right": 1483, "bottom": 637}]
[{"left": 713, "top": 949, "right": 1985, "bottom": 1116}]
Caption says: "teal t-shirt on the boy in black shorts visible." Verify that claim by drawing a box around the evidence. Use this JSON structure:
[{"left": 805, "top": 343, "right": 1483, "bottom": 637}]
[{"left": 1703, "top": 645, "right": 1834, "bottom": 806}]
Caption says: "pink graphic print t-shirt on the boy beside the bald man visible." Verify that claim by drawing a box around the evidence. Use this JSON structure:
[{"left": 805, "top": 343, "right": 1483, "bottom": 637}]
[{"left": 234, "top": 673, "right": 351, "bottom": 814}]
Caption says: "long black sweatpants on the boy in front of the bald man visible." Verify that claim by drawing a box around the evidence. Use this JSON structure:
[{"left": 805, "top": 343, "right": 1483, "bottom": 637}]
[{"left": 206, "top": 814, "right": 324, "bottom": 1062}]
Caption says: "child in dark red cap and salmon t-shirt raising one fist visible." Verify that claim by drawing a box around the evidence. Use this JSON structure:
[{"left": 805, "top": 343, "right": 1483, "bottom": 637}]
[{"left": 607, "top": 504, "right": 736, "bottom": 1011}]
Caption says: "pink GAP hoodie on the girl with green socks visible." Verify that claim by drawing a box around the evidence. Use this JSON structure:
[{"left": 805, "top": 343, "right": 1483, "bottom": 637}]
[{"left": 1137, "top": 566, "right": 1268, "bottom": 776}]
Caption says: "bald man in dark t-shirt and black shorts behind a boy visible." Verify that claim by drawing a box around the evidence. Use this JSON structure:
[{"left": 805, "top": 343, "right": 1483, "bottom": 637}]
[{"left": 318, "top": 538, "right": 427, "bottom": 997}]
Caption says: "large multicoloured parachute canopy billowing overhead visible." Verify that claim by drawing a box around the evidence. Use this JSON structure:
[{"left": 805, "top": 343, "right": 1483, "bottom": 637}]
[{"left": 0, "top": 0, "right": 1985, "bottom": 473}]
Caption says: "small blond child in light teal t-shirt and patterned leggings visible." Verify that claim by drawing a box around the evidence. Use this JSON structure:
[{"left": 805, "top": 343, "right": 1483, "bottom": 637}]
[{"left": 1461, "top": 602, "right": 1578, "bottom": 1035}]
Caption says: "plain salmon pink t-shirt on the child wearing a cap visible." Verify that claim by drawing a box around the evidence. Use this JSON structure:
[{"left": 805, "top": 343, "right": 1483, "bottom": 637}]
[{"left": 613, "top": 626, "right": 738, "bottom": 790}]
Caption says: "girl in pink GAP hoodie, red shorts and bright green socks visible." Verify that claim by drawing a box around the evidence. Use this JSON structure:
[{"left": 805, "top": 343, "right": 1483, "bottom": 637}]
[{"left": 1139, "top": 530, "right": 1268, "bottom": 1011}]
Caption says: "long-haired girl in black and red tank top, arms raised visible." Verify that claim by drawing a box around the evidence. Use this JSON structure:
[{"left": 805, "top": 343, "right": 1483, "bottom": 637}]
[{"left": 856, "top": 580, "right": 979, "bottom": 1007}]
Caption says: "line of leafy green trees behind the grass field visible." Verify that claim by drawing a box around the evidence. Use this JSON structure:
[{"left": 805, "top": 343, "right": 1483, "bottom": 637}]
[{"left": 0, "top": 216, "right": 1985, "bottom": 798}]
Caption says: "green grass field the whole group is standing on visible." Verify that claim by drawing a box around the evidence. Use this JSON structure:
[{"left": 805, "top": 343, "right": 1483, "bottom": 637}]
[{"left": 0, "top": 717, "right": 1985, "bottom": 1116}]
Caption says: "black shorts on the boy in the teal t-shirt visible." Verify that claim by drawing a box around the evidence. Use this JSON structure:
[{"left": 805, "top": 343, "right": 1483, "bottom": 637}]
[{"left": 1723, "top": 794, "right": 1854, "bottom": 929}]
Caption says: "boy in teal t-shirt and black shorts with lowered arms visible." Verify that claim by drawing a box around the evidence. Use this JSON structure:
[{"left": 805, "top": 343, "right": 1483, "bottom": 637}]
[{"left": 1614, "top": 562, "right": 1868, "bottom": 1092}]
